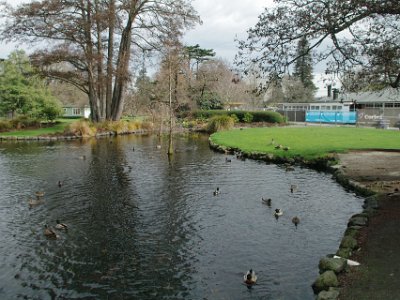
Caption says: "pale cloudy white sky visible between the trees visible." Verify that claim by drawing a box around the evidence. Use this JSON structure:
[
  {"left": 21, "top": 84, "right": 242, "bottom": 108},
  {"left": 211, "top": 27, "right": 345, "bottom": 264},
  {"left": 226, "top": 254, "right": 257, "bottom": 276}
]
[{"left": 0, "top": 0, "right": 332, "bottom": 96}]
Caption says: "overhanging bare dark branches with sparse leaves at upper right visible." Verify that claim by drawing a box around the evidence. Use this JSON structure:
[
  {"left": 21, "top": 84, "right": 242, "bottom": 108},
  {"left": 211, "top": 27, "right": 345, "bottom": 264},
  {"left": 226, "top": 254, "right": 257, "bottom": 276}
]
[{"left": 238, "top": 0, "right": 400, "bottom": 88}]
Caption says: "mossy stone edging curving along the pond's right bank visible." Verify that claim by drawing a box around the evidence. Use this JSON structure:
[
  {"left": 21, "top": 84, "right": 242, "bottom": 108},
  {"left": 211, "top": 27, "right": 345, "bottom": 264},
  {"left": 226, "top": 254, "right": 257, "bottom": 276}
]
[{"left": 209, "top": 139, "right": 379, "bottom": 300}]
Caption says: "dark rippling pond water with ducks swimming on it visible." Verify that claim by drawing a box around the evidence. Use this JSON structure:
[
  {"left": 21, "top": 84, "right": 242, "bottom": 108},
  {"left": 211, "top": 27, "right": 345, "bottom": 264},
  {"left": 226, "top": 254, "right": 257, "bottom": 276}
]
[{"left": 0, "top": 135, "right": 362, "bottom": 300}]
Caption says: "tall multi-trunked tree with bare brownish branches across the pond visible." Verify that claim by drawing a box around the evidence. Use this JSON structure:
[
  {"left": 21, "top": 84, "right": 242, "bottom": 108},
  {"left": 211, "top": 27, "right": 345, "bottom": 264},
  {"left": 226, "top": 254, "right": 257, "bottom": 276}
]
[{"left": 2, "top": 0, "right": 198, "bottom": 121}]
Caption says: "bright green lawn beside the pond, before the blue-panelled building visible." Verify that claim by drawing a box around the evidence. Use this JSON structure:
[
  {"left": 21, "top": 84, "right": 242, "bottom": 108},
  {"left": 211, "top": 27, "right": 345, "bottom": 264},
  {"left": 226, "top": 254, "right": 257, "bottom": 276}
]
[{"left": 211, "top": 126, "right": 400, "bottom": 159}]
